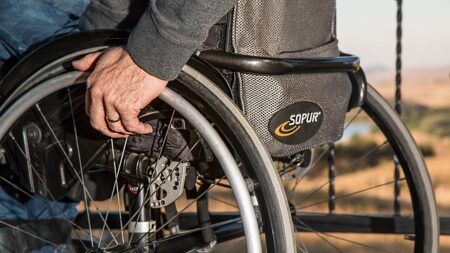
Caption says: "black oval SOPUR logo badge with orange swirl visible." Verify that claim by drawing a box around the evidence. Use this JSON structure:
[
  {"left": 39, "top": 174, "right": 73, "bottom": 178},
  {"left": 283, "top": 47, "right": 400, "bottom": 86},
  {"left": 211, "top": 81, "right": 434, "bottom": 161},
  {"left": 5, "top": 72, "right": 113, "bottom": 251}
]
[{"left": 269, "top": 101, "right": 323, "bottom": 144}]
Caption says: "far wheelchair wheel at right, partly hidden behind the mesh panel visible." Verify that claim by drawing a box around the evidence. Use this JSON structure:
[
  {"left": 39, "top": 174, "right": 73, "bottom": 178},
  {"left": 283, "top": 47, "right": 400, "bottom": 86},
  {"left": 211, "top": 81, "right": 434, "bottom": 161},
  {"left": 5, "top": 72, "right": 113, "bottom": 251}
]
[{"left": 278, "top": 86, "right": 439, "bottom": 253}]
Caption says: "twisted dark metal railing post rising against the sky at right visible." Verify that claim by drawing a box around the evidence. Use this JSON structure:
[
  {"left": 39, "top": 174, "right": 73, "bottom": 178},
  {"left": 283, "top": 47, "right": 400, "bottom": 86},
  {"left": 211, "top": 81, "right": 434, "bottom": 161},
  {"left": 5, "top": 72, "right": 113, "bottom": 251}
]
[{"left": 394, "top": 0, "right": 403, "bottom": 215}]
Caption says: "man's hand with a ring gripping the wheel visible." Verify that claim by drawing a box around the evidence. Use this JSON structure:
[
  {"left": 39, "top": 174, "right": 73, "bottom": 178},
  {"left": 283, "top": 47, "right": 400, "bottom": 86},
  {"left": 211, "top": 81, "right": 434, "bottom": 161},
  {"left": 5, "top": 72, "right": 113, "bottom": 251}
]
[{"left": 72, "top": 47, "right": 167, "bottom": 138}]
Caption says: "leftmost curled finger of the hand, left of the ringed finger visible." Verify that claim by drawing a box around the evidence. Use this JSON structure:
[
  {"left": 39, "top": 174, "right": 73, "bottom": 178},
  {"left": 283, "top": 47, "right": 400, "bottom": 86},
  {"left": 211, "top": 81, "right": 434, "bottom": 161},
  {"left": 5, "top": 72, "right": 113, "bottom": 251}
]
[{"left": 89, "top": 89, "right": 127, "bottom": 138}]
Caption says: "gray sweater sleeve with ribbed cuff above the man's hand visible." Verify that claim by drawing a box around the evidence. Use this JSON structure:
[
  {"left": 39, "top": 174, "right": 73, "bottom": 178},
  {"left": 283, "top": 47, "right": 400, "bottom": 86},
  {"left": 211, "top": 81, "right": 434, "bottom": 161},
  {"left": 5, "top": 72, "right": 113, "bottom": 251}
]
[{"left": 127, "top": 0, "right": 236, "bottom": 80}]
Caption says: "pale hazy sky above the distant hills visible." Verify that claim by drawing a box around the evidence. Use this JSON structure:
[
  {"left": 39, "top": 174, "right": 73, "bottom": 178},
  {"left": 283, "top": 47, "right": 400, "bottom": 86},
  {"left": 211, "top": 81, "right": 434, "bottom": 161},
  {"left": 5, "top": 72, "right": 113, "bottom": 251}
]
[{"left": 337, "top": 0, "right": 450, "bottom": 70}]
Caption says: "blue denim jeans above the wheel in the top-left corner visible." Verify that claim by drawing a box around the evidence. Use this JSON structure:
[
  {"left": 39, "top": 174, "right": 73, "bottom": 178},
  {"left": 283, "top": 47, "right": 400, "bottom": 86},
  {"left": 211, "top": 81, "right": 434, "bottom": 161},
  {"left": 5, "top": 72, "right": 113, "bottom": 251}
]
[{"left": 0, "top": 0, "right": 89, "bottom": 61}]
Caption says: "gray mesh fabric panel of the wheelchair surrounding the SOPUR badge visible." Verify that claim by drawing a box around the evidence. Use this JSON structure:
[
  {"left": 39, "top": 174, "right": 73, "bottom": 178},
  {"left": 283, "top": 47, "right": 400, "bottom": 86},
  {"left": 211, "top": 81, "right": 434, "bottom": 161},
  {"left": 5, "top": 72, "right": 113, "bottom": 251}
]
[{"left": 232, "top": 0, "right": 351, "bottom": 157}]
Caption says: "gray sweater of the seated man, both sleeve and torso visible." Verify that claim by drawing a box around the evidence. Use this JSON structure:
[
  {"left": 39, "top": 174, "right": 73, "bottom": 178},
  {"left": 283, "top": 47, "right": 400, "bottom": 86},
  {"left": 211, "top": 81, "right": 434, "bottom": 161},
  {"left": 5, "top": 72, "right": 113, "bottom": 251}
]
[{"left": 81, "top": 0, "right": 236, "bottom": 80}]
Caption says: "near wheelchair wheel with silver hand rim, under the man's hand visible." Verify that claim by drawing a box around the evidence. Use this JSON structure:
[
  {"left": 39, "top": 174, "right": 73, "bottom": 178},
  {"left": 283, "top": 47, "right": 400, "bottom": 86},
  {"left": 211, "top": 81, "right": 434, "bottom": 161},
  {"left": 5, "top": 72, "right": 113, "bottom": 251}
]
[{"left": 0, "top": 31, "right": 295, "bottom": 252}]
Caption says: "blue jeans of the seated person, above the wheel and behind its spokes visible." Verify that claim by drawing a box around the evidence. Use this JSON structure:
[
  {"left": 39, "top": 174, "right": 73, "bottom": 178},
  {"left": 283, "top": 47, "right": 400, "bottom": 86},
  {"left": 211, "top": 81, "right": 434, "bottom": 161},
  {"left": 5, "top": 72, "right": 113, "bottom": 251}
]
[{"left": 0, "top": 0, "right": 89, "bottom": 253}]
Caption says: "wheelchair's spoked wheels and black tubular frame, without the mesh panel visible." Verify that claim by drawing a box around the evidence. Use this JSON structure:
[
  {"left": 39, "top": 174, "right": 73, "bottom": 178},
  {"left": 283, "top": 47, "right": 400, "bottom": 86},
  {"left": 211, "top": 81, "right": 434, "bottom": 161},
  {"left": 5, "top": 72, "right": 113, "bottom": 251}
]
[{"left": 0, "top": 30, "right": 439, "bottom": 253}]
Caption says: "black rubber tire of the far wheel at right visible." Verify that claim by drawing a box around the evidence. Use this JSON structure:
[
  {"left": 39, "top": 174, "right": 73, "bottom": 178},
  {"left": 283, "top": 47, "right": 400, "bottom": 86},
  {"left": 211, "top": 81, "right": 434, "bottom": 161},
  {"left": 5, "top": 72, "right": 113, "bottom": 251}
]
[{"left": 362, "top": 85, "right": 439, "bottom": 253}]
